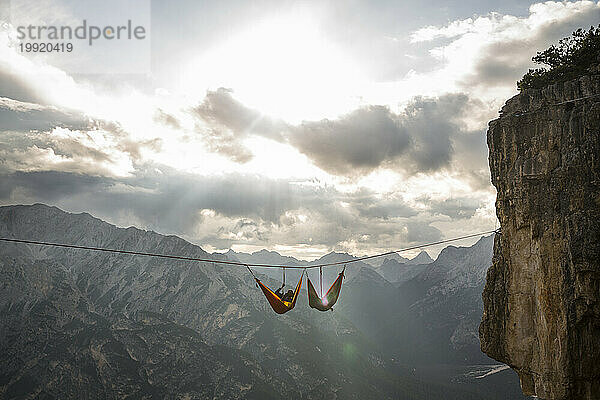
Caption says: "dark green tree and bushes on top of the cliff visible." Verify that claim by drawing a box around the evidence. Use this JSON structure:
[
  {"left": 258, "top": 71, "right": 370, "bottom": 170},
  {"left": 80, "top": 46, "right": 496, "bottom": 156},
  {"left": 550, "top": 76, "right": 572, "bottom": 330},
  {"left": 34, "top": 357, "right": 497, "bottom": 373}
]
[{"left": 517, "top": 25, "right": 600, "bottom": 91}]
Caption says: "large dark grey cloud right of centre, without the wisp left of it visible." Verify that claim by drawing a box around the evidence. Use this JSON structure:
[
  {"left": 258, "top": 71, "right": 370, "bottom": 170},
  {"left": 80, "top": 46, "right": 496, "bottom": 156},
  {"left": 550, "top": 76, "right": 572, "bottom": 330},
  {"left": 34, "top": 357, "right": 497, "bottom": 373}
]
[{"left": 289, "top": 94, "right": 476, "bottom": 176}]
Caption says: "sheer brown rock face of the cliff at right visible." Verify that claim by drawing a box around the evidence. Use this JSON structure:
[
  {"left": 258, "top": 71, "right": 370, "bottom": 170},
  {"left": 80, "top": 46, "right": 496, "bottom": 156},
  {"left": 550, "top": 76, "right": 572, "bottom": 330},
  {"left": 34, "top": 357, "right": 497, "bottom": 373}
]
[{"left": 479, "top": 75, "right": 600, "bottom": 399}]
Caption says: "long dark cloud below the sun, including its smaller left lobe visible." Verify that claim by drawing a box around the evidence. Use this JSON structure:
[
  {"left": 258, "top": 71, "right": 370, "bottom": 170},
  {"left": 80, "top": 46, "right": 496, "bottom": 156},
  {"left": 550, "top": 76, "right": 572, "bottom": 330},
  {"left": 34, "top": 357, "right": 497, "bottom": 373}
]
[{"left": 193, "top": 89, "right": 473, "bottom": 177}]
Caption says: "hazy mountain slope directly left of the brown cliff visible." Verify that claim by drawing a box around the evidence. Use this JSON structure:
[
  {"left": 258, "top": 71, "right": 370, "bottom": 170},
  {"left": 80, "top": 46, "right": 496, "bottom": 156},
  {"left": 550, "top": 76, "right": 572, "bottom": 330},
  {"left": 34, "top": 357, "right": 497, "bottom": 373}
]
[{"left": 377, "top": 235, "right": 493, "bottom": 362}]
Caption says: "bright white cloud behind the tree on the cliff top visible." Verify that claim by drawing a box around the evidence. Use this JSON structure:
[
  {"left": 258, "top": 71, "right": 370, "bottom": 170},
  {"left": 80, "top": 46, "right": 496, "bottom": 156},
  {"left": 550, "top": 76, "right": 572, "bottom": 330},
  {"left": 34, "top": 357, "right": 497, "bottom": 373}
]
[{"left": 411, "top": 1, "right": 600, "bottom": 92}]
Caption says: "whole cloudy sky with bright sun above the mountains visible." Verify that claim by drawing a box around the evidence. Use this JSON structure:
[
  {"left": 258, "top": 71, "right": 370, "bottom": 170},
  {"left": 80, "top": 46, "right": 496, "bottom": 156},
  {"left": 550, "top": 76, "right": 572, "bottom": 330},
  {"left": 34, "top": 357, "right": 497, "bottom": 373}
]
[{"left": 0, "top": 0, "right": 600, "bottom": 260}]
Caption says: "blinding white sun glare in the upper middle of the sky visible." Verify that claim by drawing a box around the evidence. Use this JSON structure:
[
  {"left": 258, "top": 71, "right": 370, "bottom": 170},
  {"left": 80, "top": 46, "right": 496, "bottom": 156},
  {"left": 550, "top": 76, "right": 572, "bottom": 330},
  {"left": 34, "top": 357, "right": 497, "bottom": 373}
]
[{"left": 188, "top": 14, "right": 364, "bottom": 123}]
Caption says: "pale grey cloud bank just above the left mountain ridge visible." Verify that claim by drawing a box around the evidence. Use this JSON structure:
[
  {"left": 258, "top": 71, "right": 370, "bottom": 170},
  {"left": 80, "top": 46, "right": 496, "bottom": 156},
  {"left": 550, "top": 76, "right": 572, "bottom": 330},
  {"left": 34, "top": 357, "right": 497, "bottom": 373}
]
[{"left": 3, "top": 166, "right": 301, "bottom": 233}]
